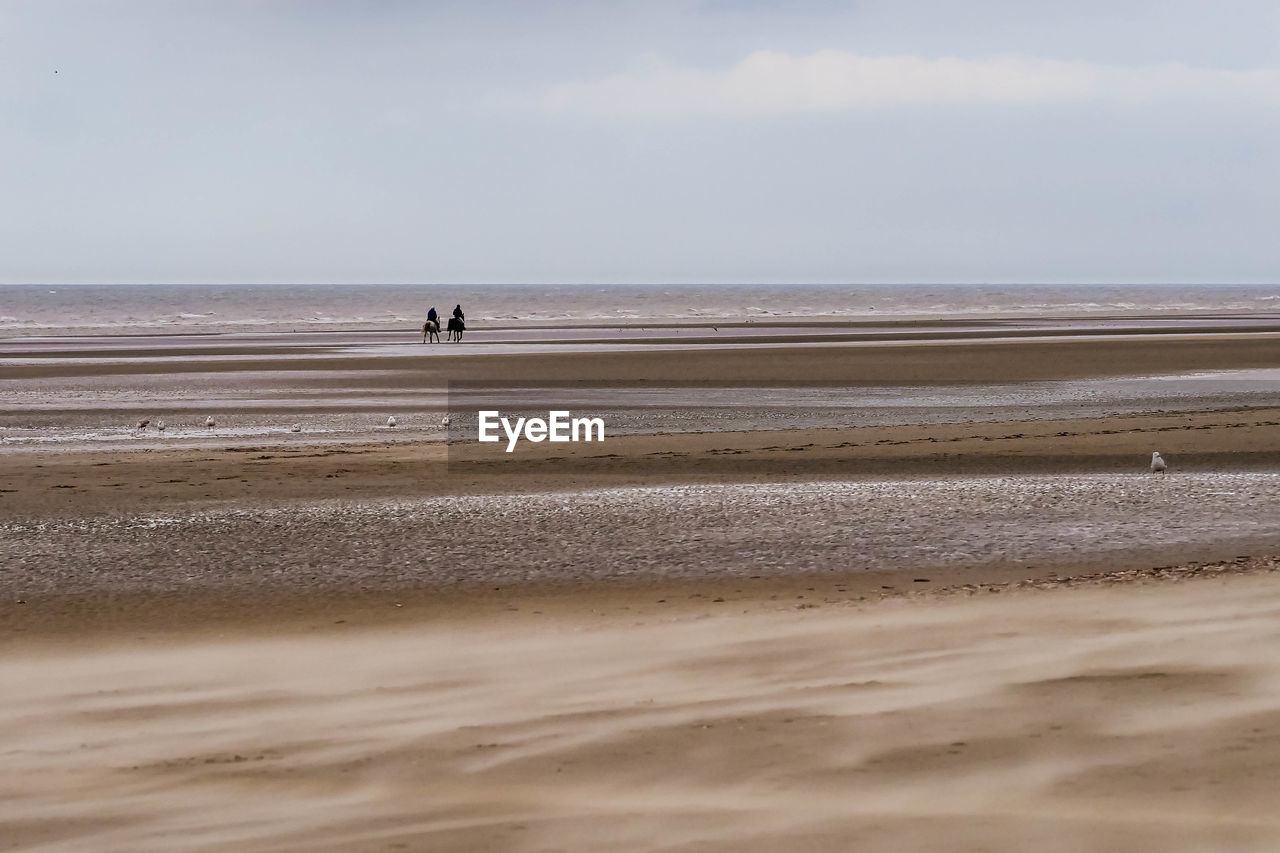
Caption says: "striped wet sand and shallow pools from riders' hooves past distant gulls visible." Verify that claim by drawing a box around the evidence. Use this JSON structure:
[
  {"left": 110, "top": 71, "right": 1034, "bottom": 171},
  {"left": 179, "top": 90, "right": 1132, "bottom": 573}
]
[{"left": 0, "top": 325, "right": 1280, "bottom": 455}]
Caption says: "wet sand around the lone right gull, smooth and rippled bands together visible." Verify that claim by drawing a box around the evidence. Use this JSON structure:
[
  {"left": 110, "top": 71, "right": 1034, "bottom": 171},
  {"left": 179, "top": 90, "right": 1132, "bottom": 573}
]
[{"left": 0, "top": 410, "right": 1280, "bottom": 639}]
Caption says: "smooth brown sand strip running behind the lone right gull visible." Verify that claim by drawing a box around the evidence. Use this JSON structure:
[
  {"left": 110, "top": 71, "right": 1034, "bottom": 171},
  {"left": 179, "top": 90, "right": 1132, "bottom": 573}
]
[{"left": 0, "top": 406, "right": 1280, "bottom": 507}]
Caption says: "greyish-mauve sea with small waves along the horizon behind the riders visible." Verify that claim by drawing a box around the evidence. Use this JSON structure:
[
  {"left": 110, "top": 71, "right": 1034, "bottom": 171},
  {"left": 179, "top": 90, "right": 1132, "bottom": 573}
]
[{"left": 0, "top": 284, "right": 1280, "bottom": 337}]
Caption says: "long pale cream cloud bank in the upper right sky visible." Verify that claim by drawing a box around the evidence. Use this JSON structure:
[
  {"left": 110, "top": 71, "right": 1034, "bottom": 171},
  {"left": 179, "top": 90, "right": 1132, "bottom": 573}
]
[{"left": 538, "top": 50, "right": 1280, "bottom": 117}]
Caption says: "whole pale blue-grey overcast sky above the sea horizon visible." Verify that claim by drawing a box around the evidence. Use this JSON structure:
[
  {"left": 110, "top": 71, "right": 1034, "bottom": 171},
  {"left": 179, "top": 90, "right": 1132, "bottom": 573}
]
[{"left": 0, "top": 0, "right": 1280, "bottom": 283}]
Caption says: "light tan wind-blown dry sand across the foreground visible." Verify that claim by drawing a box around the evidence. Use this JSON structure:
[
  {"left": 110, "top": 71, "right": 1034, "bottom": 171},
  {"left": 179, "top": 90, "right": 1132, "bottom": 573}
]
[{"left": 0, "top": 560, "right": 1280, "bottom": 853}]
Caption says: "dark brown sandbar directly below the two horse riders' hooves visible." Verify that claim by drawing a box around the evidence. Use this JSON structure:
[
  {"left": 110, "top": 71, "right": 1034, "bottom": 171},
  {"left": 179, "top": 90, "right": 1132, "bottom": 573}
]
[{"left": 0, "top": 329, "right": 1280, "bottom": 379}]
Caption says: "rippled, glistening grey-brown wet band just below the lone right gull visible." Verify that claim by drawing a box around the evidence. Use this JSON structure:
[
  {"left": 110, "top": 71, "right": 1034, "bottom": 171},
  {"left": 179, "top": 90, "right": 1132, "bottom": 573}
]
[{"left": 0, "top": 471, "right": 1280, "bottom": 594}]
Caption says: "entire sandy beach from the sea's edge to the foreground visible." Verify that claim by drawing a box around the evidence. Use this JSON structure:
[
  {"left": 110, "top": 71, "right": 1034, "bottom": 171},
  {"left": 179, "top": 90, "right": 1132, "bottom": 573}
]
[{"left": 0, "top": 308, "right": 1280, "bottom": 850}]
